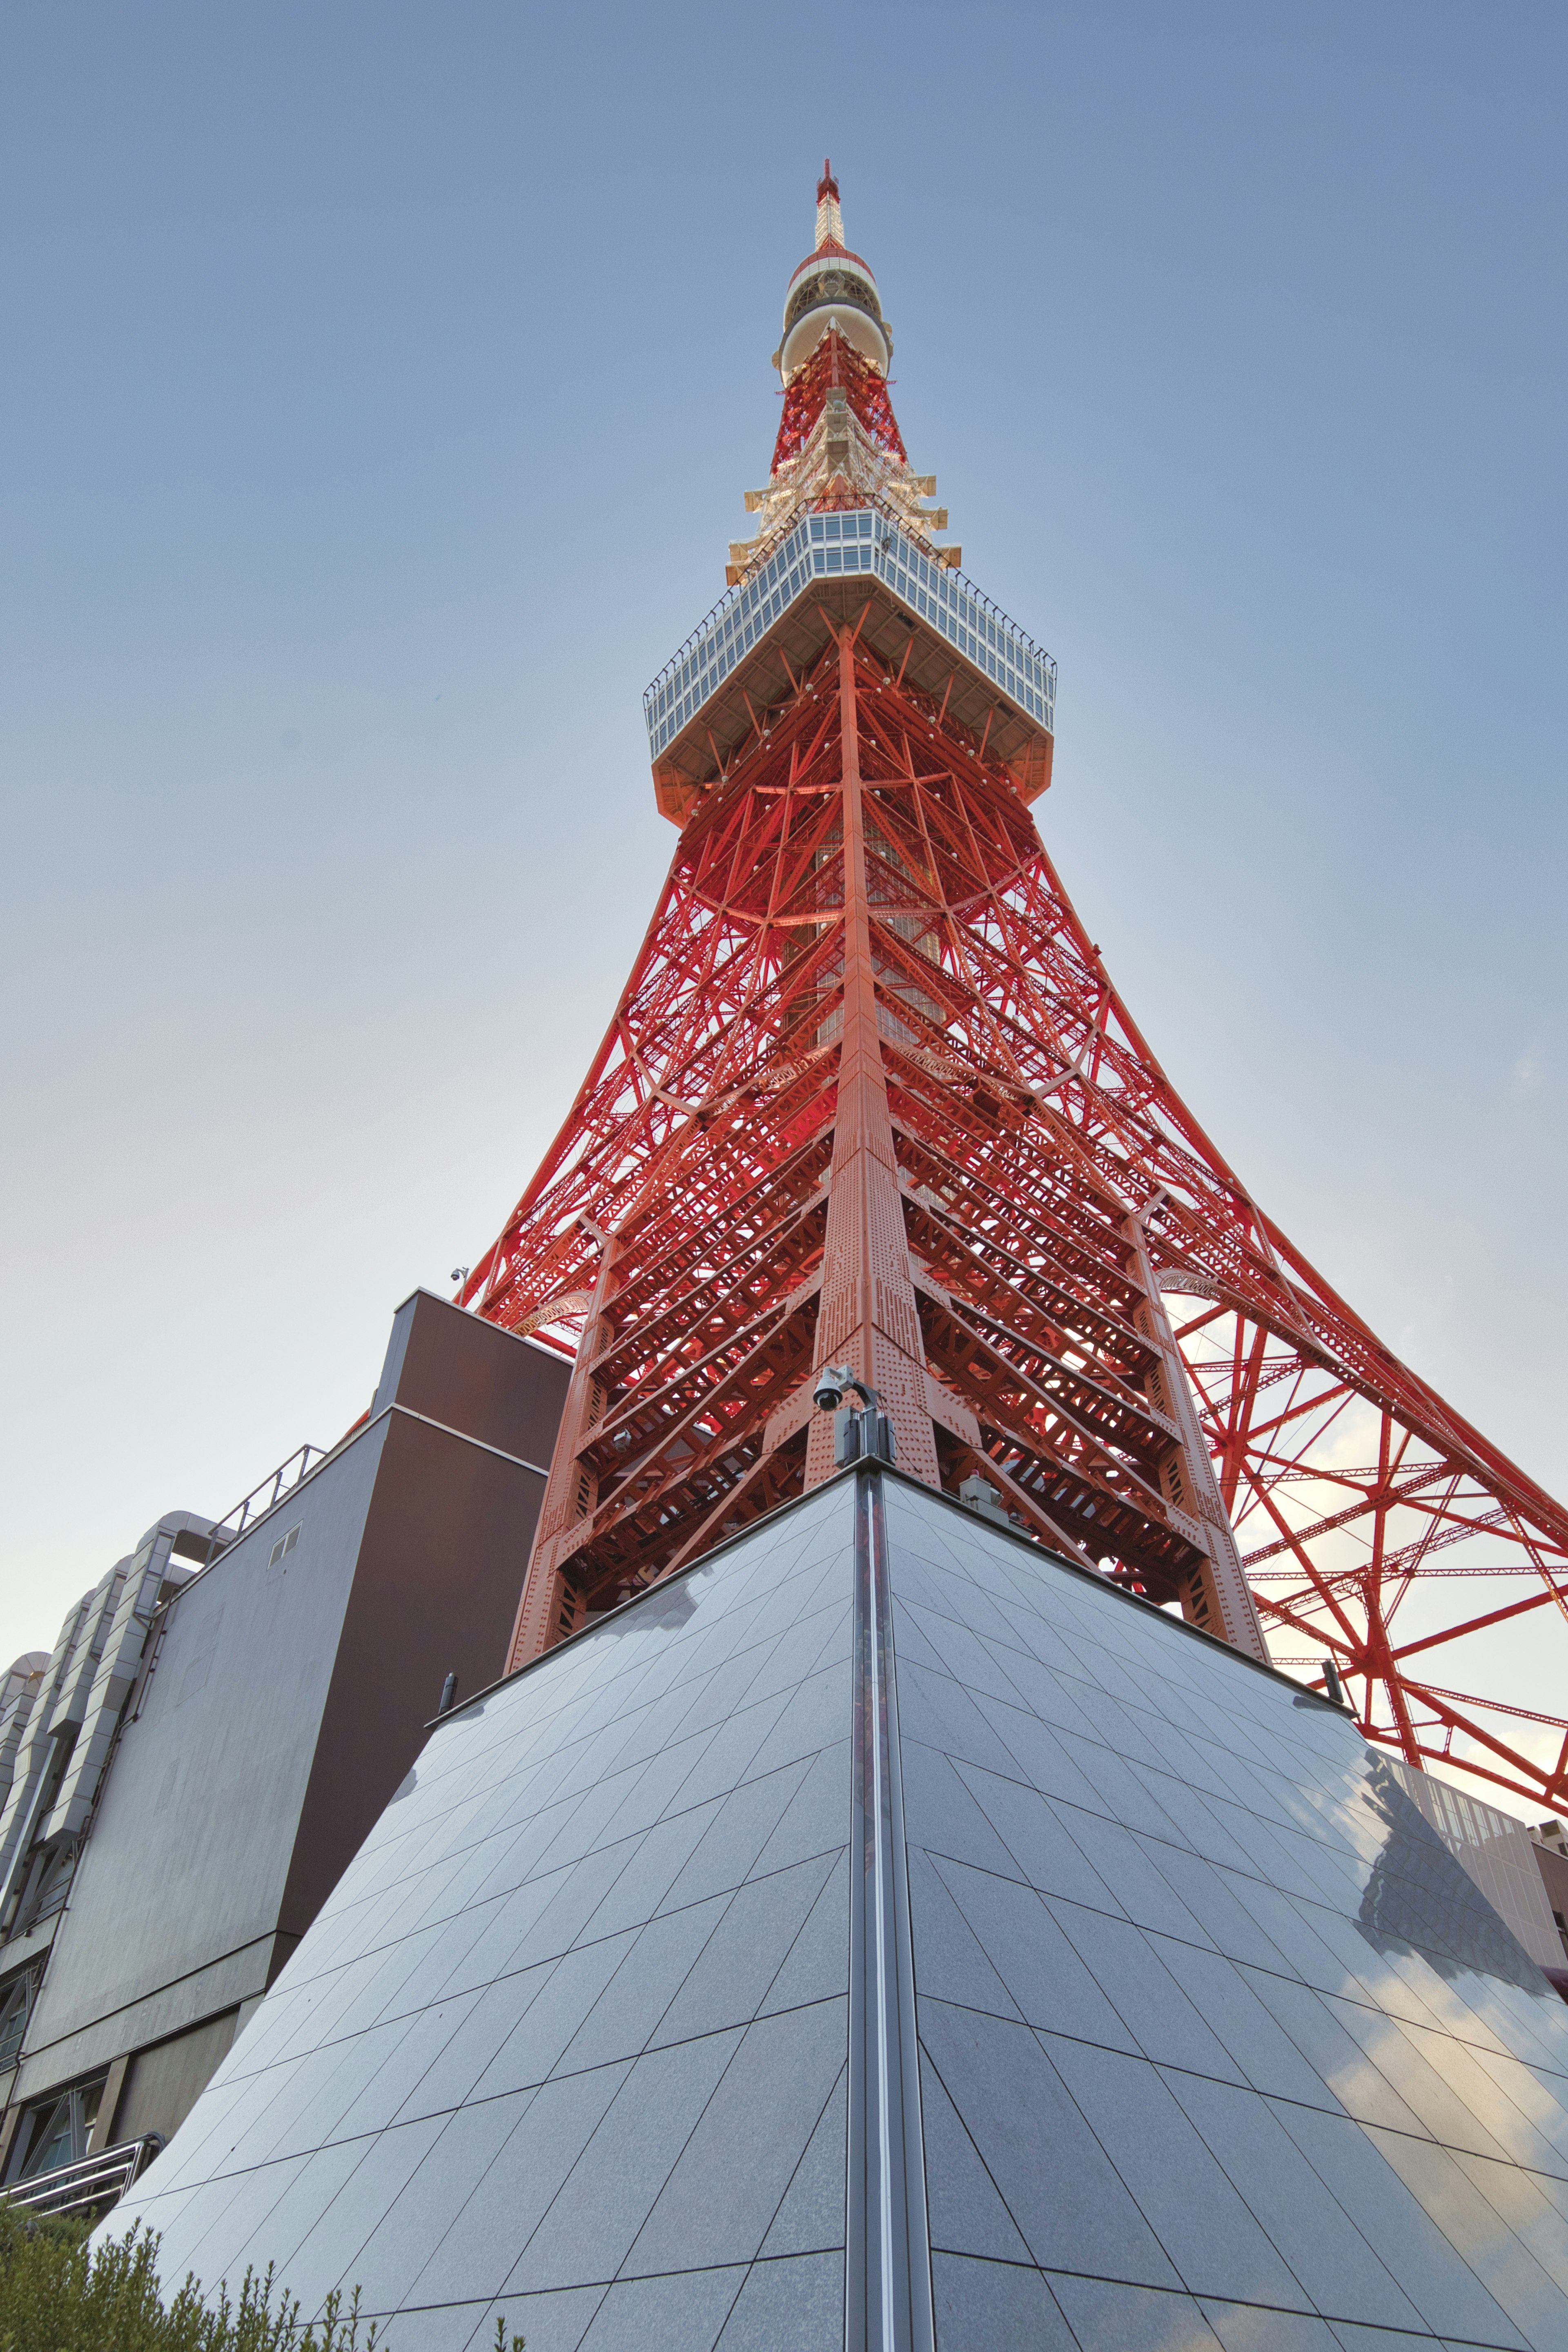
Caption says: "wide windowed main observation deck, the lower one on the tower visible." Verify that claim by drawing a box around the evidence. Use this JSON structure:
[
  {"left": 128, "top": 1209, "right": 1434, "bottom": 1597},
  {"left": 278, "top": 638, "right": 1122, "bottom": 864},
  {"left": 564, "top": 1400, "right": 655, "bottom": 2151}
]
[{"left": 642, "top": 506, "right": 1056, "bottom": 823}]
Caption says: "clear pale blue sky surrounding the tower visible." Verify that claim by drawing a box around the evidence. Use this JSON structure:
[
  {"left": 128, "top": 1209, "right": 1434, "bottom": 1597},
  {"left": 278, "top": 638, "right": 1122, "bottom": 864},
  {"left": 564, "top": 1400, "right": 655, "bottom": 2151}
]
[{"left": 0, "top": 0, "right": 1568, "bottom": 1797}]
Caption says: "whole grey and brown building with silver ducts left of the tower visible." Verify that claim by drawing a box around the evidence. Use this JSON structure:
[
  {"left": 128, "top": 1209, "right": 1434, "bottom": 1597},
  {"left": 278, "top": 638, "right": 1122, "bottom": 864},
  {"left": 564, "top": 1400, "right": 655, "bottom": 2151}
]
[{"left": 0, "top": 1291, "right": 569, "bottom": 2183}]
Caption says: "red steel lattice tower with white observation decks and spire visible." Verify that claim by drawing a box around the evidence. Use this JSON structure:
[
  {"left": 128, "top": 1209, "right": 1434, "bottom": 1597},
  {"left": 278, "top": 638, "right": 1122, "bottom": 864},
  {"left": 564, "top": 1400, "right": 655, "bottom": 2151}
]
[{"left": 461, "top": 169, "right": 1568, "bottom": 1806}]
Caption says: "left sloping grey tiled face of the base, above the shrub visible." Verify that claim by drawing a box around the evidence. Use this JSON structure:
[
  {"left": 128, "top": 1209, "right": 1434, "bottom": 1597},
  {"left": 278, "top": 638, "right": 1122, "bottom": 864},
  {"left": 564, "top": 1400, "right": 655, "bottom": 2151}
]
[{"left": 104, "top": 1489, "right": 851, "bottom": 2352}]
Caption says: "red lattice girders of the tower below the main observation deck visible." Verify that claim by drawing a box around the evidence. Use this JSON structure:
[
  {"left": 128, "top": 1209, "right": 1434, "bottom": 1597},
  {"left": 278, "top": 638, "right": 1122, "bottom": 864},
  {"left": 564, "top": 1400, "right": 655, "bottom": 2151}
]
[{"left": 463, "top": 588, "right": 1568, "bottom": 1806}]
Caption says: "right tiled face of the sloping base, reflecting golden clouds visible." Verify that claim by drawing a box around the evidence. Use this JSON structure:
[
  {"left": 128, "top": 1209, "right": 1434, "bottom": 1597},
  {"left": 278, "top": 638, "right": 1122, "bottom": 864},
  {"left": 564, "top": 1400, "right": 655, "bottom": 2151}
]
[{"left": 889, "top": 1482, "right": 1568, "bottom": 2352}]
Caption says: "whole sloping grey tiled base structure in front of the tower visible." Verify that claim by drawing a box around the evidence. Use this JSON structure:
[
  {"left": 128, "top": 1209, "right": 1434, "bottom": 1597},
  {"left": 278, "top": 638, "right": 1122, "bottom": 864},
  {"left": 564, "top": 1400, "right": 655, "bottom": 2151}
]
[{"left": 106, "top": 1465, "right": 1568, "bottom": 2352}]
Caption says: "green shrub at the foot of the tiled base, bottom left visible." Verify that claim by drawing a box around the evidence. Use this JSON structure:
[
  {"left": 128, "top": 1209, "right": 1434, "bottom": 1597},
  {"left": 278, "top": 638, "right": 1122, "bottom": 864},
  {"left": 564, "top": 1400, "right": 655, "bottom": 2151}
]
[{"left": 0, "top": 2204, "right": 522, "bottom": 2352}]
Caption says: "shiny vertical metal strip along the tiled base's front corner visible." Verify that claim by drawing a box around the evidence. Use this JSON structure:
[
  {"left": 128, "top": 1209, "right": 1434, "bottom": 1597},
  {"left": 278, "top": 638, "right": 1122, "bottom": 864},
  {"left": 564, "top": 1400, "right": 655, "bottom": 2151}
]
[{"left": 844, "top": 1470, "right": 935, "bottom": 2352}]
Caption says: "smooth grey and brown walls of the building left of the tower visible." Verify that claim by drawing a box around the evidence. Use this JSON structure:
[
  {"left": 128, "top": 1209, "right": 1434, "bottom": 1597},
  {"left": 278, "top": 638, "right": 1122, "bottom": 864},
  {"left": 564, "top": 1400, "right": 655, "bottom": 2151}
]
[{"left": 0, "top": 1291, "right": 569, "bottom": 2138}]
